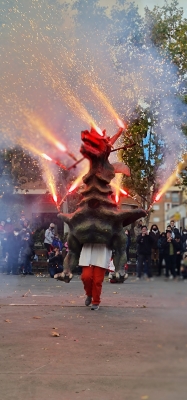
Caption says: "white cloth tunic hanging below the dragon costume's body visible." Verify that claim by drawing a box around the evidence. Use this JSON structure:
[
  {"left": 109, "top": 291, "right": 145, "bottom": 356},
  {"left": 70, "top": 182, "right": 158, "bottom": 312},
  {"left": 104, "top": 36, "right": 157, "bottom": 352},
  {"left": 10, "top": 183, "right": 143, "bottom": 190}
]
[{"left": 79, "top": 243, "right": 112, "bottom": 269}]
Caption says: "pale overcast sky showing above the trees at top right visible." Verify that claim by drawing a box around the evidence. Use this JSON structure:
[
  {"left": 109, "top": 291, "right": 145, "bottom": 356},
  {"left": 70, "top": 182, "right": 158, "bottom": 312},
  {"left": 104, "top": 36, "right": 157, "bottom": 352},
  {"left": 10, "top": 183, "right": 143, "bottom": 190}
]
[{"left": 100, "top": 0, "right": 187, "bottom": 18}]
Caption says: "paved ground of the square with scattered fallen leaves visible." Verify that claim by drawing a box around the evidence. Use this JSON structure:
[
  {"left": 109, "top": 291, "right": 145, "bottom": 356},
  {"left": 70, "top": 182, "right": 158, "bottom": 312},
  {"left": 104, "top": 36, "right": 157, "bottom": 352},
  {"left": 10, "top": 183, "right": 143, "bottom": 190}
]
[{"left": 0, "top": 274, "right": 187, "bottom": 400}]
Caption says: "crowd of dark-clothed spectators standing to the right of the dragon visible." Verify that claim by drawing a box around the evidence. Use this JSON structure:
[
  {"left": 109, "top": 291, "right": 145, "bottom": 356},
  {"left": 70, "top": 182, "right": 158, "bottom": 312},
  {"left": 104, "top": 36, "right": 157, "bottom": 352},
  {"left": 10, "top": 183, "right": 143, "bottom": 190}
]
[{"left": 132, "top": 220, "right": 187, "bottom": 280}]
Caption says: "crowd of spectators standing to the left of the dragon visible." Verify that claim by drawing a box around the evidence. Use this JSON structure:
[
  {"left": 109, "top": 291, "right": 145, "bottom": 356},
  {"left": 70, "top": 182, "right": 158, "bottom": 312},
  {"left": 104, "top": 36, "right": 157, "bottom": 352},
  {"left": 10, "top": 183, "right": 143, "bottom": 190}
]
[{"left": 0, "top": 213, "right": 67, "bottom": 277}]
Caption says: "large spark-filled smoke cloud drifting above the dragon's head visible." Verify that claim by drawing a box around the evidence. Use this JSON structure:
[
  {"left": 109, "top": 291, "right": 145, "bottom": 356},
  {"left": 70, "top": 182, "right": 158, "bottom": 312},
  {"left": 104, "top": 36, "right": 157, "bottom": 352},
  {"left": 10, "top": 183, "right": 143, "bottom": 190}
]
[{"left": 0, "top": 0, "right": 186, "bottom": 191}]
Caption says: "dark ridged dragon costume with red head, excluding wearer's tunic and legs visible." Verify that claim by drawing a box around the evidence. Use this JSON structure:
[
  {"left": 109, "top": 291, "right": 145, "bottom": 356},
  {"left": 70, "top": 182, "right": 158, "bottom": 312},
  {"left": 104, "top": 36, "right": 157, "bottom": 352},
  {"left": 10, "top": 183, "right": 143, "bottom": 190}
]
[{"left": 55, "top": 128, "right": 146, "bottom": 281}]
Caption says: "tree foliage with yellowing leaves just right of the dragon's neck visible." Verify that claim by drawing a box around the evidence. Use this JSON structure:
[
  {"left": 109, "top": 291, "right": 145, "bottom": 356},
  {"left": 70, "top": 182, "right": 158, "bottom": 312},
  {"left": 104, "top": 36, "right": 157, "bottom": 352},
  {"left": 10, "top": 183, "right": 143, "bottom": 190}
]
[{"left": 119, "top": 107, "right": 164, "bottom": 208}]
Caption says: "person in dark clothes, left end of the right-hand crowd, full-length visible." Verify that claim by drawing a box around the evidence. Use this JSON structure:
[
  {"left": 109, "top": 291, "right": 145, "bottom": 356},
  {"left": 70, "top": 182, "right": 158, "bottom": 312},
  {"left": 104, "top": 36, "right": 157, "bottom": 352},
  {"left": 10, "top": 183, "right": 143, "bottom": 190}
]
[{"left": 137, "top": 225, "right": 153, "bottom": 279}]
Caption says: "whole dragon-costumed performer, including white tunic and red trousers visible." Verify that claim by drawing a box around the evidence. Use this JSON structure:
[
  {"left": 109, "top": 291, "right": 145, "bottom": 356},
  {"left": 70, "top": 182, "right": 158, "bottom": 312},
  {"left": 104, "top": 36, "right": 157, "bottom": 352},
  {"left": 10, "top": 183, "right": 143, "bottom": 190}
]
[{"left": 55, "top": 128, "right": 146, "bottom": 306}]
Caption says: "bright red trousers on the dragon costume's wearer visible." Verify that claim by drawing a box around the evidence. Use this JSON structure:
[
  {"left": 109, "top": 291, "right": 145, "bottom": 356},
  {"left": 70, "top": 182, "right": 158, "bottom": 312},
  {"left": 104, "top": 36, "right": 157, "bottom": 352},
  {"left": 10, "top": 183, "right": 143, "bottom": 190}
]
[{"left": 81, "top": 265, "right": 105, "bottom": 304}]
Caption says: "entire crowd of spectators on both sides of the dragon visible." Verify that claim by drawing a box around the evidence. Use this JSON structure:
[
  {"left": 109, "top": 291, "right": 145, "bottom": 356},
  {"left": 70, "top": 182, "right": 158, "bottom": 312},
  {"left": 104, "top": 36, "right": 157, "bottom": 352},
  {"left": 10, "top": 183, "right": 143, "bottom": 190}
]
[{"left": 0, "top": 213, "right": 187, "bottom": 280}]
